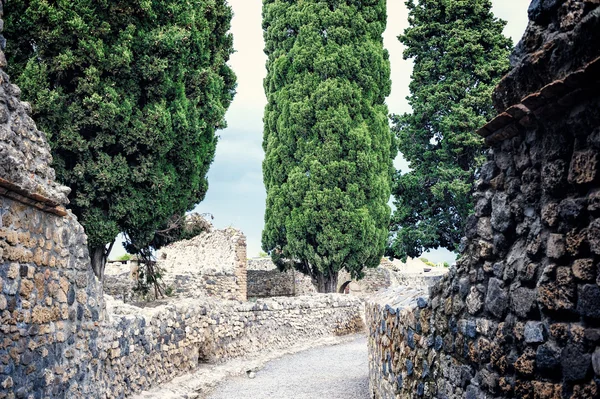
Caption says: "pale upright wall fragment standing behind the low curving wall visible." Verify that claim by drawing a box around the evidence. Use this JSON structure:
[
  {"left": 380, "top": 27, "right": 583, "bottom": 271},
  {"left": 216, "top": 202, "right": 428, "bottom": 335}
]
[{"left": 157, "top": 228, "right": 247, "bottom": 301}]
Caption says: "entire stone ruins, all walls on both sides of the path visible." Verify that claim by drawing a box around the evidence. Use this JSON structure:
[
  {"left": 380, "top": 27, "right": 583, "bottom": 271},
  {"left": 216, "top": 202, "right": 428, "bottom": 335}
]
[{"left": 0, "top": 0, "right": 600, "bottom": 399}]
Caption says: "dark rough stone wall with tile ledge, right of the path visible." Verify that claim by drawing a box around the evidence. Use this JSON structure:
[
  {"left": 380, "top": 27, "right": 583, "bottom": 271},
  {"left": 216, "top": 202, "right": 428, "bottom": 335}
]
[{"left": 366, "top": 0, "right": 600, "bottom": 399}]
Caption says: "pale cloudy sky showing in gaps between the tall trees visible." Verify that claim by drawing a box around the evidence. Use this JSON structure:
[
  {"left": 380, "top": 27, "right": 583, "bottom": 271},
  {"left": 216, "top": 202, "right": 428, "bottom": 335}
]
[{"left": 112, "top": 0, "right": 529, "bottom": 262}]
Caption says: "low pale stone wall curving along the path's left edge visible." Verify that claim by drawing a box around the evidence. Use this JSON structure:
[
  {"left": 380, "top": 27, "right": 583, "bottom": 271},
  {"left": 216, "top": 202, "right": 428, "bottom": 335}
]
[{"left": 96, "top": 295, "right": 364, "bottom": 397}]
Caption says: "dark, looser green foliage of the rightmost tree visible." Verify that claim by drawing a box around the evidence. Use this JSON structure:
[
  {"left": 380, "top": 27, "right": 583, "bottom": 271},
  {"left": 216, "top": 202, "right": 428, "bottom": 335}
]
[{"left": 387, "top": 0, "right": 512, "bottom": 260}]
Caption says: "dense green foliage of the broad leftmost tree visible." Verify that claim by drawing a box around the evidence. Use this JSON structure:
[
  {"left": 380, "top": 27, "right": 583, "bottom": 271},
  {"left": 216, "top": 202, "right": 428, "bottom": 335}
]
[{"left": 5, "top": 0, "right": 235, "bottom": 272}]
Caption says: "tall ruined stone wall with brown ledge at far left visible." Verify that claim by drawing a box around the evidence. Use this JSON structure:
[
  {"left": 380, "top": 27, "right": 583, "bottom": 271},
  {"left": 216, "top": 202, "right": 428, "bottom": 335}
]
[{"left": 0, "top": 3, "right": 103, "bottom": 398}]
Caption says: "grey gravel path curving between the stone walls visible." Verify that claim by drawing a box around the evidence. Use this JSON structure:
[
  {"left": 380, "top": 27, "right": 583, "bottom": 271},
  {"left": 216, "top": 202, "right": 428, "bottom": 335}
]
[{"left": 208, "top": 337, "right": 369, "bottom": 399}]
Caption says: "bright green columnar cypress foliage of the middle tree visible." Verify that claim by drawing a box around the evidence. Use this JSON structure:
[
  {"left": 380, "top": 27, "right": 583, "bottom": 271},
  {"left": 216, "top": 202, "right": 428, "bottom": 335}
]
[{"left": 262, "top": 0, "right": 395, "bottom": 291}]
